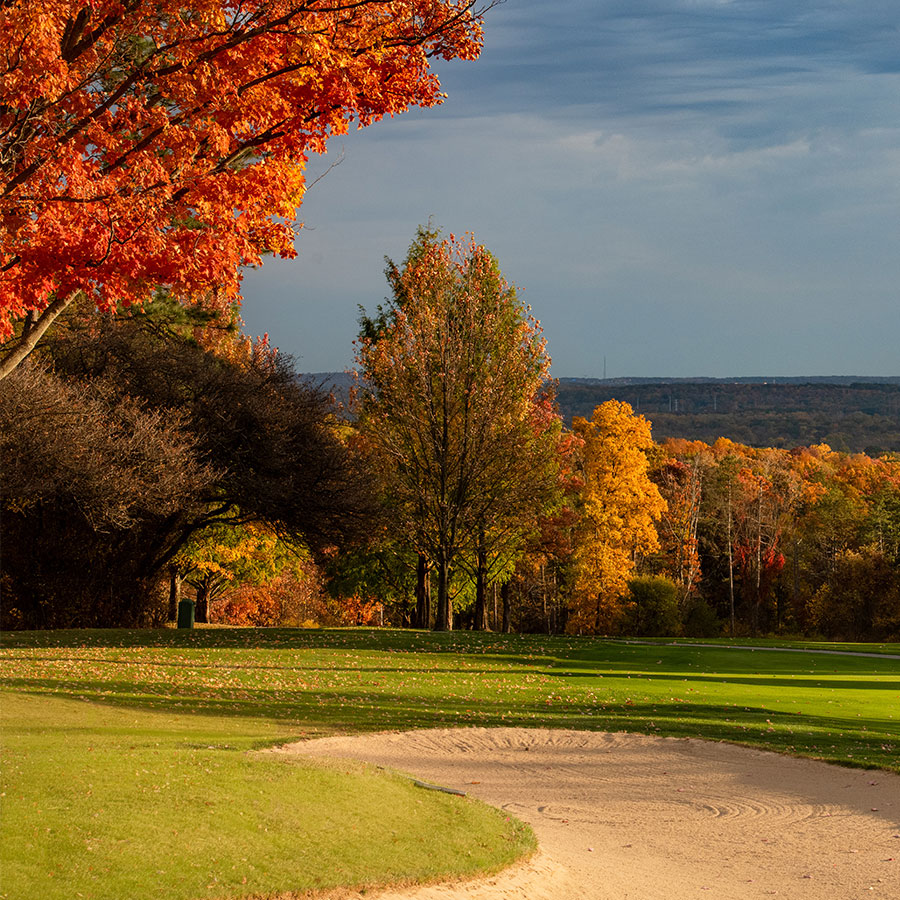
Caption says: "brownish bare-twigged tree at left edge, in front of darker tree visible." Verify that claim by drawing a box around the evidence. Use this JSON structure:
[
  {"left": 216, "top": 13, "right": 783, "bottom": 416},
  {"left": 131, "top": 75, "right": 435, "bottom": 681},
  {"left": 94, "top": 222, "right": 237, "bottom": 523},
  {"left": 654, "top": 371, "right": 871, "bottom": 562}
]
[{"left": 0, "top": 364, "right": 217, "bottom": 628}]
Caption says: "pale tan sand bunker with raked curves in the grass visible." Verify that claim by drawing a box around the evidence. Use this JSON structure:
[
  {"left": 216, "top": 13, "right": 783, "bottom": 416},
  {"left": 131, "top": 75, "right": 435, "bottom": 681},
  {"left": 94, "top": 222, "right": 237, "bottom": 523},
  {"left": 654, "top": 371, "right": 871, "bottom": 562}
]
[{"left": 280, "top": 728, "right": 900, "bottom": 900}]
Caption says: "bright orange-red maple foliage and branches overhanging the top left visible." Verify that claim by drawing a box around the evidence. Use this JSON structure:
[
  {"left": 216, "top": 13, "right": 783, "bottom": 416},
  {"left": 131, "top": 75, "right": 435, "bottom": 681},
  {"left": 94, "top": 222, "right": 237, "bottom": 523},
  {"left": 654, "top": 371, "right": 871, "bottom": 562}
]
[{"left": 0, "top": 0, "right": 483, "bottom": 377}]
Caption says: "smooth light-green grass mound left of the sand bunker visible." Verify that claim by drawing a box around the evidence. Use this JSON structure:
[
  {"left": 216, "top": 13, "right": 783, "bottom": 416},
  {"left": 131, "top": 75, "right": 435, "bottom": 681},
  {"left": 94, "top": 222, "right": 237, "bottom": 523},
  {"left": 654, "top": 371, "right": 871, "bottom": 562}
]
[{"left": 0, "top": 693, "right": 534, "bottom": 900}]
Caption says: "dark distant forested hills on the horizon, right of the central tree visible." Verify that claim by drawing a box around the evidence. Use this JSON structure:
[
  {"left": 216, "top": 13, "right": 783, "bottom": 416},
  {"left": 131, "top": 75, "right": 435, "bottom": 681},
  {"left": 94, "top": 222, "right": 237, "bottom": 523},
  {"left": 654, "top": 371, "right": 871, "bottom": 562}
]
[{"left": 557, "top": 377, "right": 900, "bottom": 456}]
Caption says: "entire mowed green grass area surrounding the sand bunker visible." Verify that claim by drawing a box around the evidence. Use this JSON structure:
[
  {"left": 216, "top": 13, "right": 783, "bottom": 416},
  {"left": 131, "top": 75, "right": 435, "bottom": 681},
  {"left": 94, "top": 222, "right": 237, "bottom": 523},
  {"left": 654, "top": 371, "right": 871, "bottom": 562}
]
[{"left": 0, "top": 629, "right": 900, "bottom": 900}]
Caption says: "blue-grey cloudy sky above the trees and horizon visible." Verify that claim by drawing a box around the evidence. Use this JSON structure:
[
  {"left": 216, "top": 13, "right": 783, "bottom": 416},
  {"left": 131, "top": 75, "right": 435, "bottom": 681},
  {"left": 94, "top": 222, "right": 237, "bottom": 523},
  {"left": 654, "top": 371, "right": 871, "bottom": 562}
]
[{"left": 242, "top": 0, "right": 900, "bottom": 378}]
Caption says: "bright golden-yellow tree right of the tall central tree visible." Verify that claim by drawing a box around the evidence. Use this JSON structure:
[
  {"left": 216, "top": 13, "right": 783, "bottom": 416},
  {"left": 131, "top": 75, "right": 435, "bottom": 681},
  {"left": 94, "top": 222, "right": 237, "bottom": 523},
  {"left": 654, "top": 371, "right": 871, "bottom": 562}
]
[{"left": 569, "top": 400, "right": 666, "bottom": 633}]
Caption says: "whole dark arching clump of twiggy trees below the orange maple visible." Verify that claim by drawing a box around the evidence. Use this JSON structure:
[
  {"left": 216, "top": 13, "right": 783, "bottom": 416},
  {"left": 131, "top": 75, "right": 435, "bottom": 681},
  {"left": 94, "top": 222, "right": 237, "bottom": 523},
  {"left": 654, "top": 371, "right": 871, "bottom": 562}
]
[{"left": 0, "top": 314, "right": 371, "bottom": 627}]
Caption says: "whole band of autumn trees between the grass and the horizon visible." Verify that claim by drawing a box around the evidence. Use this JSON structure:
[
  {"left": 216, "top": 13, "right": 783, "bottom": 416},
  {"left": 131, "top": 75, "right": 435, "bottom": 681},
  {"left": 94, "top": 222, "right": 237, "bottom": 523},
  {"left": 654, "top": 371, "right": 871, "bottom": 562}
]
[{"left": 0, "top": 228, "right": 900, "bottom": 640}]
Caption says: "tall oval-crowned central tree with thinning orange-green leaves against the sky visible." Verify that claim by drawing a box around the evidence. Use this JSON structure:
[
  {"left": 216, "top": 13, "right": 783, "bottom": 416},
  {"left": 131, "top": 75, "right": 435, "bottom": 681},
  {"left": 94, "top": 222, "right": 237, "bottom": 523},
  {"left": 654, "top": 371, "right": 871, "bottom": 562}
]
[{"left": 357, "top": 229, "right": 558, "bottom": 630}]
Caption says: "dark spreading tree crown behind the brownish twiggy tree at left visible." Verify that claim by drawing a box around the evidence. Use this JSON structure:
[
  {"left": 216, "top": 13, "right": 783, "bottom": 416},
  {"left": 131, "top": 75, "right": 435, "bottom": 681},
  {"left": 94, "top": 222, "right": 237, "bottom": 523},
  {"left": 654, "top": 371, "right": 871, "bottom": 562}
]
[{"left": 54, "top": 317, "right": 369, "bottom": 550}]
